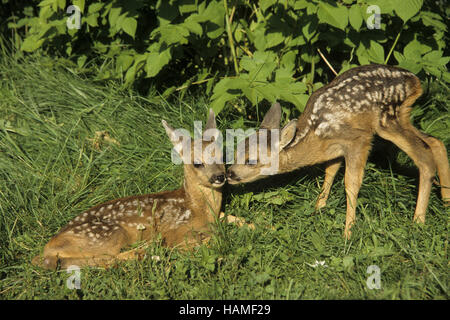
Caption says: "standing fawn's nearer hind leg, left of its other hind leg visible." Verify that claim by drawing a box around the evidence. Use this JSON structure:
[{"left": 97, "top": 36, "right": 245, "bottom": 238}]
[{"left": 377, "top": 124, "right": 436, "bottom": 223}]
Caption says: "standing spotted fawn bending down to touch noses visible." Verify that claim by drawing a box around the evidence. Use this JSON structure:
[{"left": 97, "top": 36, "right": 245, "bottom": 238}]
[{"left": 227, "top": 65, "right": 450, "bottom": 239}]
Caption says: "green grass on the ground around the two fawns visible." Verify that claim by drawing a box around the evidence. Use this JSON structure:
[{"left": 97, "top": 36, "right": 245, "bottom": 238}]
[{"left": 0, "top": 52, "right": 450, "bottom": 299}]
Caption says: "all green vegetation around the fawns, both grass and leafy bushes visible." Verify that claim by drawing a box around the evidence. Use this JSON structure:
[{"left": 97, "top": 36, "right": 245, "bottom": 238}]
[{"left": 0, "top": 0, "right": 450, "bottom": 299}]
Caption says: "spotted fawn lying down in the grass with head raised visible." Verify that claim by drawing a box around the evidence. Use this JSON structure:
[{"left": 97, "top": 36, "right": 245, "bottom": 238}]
[{"left": 33, "top": 111, "right": 240, "bottom": 269}]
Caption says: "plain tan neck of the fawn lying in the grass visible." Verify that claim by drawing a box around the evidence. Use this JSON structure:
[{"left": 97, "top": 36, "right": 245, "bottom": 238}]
[{"left": 183, "top": 180, "right": 222, "bottom": 222}]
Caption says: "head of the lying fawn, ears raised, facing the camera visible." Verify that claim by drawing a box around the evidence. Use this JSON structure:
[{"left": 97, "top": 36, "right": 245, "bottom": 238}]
[{"left": 162, "top": 110, "right": 226, "bottom": 188}]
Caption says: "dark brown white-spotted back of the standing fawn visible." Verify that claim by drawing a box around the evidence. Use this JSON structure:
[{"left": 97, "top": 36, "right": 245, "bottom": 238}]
[{"left": 296, "top": 65, "right": 422, "bottom": 141}]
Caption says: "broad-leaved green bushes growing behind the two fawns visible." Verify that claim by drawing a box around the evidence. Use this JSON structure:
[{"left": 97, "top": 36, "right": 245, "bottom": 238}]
[{"left": 3, "top": 0, "right": 450, "bottom": 113}]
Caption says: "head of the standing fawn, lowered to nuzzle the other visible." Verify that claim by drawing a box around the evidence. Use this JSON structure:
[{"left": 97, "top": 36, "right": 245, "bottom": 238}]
[{"left": 227, "top": 103, "right": 296, "bottom": 184}]
